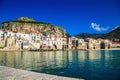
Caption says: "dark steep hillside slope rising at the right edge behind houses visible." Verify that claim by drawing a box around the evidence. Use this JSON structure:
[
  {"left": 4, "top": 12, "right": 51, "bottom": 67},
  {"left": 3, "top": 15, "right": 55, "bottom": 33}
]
[{"left": 105, "top": 27, "right": 120, "bottom": 39}]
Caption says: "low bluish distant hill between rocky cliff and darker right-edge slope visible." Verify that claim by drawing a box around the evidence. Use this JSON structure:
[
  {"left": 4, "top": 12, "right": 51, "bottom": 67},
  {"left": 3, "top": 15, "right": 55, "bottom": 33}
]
[{"left": 75, "top": 33, "right": 105, "bottom": 39}]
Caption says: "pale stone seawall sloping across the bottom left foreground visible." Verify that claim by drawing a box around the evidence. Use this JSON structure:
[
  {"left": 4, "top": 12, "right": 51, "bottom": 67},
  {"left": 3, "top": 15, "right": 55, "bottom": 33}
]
[{"left": 0, "top": 66, "right": 84, "bottom": 80}]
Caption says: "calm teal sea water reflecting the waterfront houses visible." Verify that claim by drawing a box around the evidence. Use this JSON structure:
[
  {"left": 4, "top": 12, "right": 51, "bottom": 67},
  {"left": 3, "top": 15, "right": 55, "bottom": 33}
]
[{"left": 0, "top": 50, "right": 120, "bottom": 80}]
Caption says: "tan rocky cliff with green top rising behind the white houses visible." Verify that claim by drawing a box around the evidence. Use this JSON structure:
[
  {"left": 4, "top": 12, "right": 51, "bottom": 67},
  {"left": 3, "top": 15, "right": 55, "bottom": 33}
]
[{"left": 2, "top": 17, "right": 66, "bottom": 36}]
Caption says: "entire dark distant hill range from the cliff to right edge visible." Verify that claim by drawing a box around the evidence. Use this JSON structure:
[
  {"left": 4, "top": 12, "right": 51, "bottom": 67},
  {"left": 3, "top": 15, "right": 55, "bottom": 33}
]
[{"left": 75, "top": 27, "right": 120, "bottom": 39}]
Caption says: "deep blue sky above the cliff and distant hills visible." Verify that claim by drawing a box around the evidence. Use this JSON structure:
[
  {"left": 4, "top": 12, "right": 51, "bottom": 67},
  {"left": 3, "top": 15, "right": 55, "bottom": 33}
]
[{"left": 0, "top": 0, "right": 120, "bottom": 35}]
